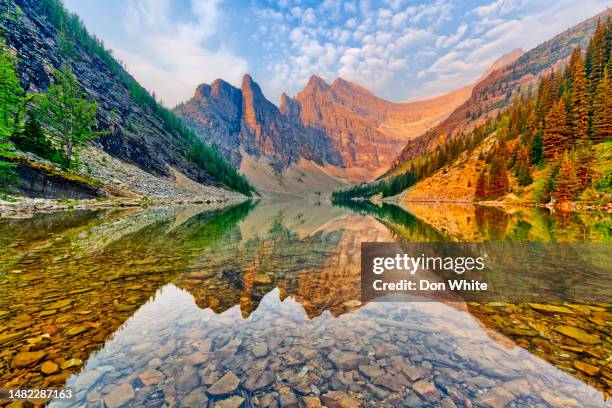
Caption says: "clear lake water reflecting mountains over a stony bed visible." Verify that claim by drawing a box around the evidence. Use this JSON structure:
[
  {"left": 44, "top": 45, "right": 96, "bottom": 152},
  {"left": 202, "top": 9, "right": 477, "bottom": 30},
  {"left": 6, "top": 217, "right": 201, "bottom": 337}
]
[{"left": 0, "top": 201, "right": 611, "bottom": 407}]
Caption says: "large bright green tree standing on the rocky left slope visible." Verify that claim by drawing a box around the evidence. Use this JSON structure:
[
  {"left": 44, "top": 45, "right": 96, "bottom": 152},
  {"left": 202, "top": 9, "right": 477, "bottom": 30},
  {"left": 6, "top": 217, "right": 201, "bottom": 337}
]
[{"left": 42, "top": 65, "right": 105, "bottom": 165}]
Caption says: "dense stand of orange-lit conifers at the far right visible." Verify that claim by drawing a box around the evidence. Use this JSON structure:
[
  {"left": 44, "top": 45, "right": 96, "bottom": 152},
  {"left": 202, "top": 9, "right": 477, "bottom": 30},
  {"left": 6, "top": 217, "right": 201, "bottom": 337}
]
[{"left": 475, "top": 19, "right": 612, "bottom": 206}]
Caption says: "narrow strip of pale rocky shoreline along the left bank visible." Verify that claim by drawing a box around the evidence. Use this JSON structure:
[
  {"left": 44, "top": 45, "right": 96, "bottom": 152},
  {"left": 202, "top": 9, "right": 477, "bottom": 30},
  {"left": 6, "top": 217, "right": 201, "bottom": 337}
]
[{"left": 0, "top": 196, "right": 252, "bottom": 219}]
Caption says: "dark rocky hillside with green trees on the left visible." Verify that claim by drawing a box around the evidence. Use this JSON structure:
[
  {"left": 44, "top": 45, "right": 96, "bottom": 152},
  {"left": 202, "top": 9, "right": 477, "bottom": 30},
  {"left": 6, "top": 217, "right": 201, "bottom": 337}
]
[{"left": 0, "top": 0, "right": 253, "bottom": 195}]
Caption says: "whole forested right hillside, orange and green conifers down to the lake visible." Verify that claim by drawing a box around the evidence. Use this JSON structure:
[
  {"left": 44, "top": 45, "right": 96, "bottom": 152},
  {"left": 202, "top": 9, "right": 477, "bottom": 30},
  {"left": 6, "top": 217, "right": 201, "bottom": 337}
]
[{"left": 334, "top": 18, "right": 612, "bottom": 207}]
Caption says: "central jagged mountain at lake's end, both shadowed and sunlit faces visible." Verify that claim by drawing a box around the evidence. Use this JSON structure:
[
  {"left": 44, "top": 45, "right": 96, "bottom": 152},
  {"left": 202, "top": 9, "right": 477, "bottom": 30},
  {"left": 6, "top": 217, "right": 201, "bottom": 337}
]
[{"left": 175, "top": 75, "right": 471, "bottom": 185}]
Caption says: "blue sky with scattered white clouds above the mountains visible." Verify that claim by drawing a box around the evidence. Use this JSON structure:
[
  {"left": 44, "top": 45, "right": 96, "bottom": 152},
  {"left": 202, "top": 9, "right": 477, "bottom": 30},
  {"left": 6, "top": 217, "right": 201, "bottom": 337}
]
[{"left": 64, "top": 0, "right": 609, "bottom": 107}]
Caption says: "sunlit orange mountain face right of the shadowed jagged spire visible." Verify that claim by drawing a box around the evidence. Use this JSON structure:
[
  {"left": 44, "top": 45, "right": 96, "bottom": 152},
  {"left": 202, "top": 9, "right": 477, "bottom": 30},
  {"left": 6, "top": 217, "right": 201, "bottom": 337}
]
[{"left": 292, "top": 76, "right": 471, "bottom": 176}]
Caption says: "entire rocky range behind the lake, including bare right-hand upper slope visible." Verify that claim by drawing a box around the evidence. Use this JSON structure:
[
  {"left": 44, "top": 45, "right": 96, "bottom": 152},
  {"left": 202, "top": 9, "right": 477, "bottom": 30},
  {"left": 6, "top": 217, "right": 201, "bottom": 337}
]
[{"left": 174, "top": 11, "right": 609, "bottom": 195}]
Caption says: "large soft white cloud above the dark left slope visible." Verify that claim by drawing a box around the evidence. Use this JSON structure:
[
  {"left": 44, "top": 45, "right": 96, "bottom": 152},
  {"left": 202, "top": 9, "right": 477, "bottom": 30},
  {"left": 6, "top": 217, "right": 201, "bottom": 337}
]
[{"left": 120, "top": 0, "right": 248, "bottom": 107}]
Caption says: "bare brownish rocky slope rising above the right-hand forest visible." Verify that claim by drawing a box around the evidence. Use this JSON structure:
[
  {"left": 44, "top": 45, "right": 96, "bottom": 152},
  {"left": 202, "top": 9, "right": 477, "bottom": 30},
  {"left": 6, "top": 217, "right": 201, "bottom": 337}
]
[{"left": 392, "top": 9, "right": 612, "bottom": 168}]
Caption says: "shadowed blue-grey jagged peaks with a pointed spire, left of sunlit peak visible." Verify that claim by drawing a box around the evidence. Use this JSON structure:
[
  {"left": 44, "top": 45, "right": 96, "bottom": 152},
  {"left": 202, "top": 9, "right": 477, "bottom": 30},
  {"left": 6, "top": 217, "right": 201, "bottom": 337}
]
[{"left": 175, "top": 75, "right": 342, "bottom": 172}]
